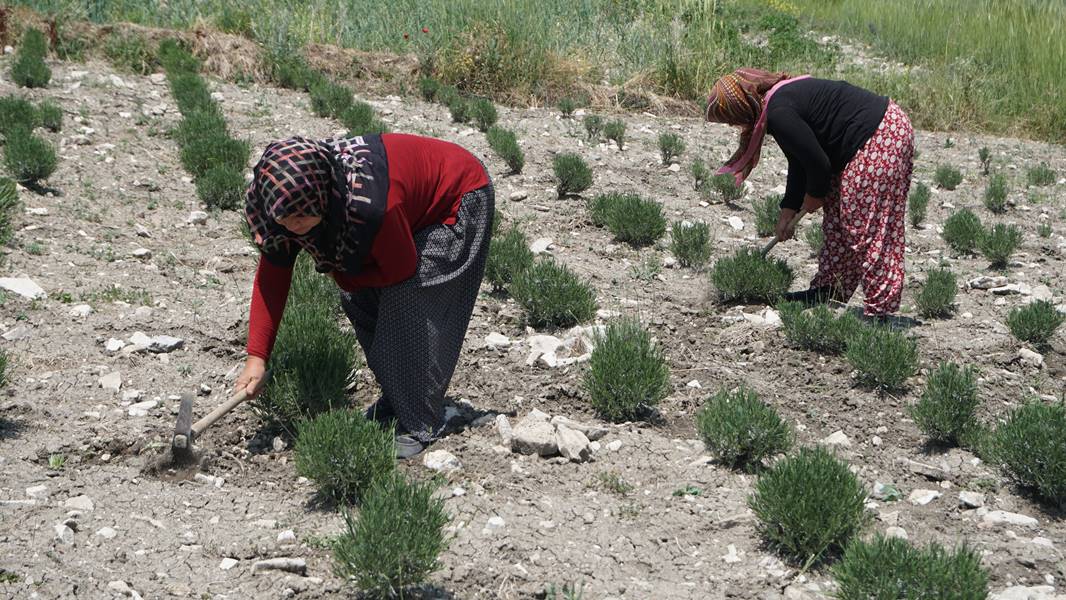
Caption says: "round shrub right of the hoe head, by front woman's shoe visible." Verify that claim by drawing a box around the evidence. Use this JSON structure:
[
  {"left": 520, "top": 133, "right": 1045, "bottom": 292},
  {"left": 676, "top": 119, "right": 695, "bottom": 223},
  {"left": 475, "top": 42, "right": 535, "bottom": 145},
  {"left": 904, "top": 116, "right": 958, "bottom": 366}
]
[{"left": 293, "top": 408, "right": 395, "bottom": 502}]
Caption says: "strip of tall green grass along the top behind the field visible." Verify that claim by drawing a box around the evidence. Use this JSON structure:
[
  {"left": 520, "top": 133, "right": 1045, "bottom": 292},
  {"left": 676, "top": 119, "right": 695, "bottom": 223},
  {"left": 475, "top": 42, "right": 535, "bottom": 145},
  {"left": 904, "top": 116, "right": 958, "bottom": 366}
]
[{"left": 17, "top": 0, "right": 1066, "bottom": 142}]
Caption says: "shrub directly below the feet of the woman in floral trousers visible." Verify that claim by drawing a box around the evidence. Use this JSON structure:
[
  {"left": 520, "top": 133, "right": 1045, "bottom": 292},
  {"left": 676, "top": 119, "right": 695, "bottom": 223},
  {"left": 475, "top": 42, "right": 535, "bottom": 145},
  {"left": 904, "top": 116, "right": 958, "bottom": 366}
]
[{"left": 844, "top": 327, "right": 918, "bottom": 390}]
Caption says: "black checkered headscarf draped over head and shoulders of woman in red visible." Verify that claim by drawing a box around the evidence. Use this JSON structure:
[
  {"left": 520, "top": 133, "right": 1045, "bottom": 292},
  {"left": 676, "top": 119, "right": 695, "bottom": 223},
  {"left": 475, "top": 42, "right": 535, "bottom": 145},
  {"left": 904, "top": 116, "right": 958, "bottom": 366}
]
[{"left": 245, "top": 135, "right": 388, "bottom": 273}]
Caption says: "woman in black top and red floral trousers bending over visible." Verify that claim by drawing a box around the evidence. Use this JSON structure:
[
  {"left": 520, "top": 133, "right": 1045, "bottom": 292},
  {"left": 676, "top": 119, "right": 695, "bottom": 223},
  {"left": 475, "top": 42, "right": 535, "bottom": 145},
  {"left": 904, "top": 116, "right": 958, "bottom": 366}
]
[{"left": 707, "top": 68, "right": 915, "bottom": 315}]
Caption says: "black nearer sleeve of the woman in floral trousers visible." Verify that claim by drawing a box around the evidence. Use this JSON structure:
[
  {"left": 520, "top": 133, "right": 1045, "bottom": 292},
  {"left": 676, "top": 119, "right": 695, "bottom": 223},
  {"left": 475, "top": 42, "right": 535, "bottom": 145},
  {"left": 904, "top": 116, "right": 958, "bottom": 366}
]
[{"left": 766, "top": 107, "right": 831, "bottom": 203}]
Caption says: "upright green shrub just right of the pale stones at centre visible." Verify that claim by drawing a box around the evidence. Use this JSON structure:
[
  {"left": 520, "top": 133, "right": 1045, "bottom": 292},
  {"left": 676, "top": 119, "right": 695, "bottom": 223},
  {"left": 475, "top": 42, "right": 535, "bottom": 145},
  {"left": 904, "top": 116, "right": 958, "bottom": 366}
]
[{"left": 584, "top": 319, "right": 669, "bottom": 422}]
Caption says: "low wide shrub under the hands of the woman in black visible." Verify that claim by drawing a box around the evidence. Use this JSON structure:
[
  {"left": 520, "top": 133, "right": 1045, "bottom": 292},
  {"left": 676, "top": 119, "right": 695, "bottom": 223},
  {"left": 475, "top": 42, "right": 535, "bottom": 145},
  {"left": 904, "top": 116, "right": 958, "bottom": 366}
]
[{"left": 711, "top": 248, "right": 793, "bottom": 304}]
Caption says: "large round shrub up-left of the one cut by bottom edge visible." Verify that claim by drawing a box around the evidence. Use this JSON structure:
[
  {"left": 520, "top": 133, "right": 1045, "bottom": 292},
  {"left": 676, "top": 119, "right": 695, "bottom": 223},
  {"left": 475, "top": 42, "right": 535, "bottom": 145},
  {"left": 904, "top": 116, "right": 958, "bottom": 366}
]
[{"left": 748, "top": 447, "right": 867, "bottom": 569}]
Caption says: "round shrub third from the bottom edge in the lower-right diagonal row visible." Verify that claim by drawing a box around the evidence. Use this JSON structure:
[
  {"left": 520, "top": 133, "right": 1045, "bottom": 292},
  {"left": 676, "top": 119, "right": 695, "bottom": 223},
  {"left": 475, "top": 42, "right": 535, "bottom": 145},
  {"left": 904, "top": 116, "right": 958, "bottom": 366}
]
[{"left": 696, "top": 386, "right": 792, "bottom": 470}]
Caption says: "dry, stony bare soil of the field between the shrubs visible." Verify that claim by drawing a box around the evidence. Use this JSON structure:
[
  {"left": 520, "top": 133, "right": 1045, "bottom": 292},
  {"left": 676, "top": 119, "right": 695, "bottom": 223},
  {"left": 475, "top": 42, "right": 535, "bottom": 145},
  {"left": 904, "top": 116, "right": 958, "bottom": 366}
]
[{"left": 0, "top": 54, "right": 1066, "bottom": 600}]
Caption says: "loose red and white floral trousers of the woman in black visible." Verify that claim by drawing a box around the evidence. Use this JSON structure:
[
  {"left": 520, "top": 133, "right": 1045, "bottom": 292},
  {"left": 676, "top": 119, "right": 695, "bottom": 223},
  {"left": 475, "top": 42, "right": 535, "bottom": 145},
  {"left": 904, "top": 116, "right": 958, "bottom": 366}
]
[{"left": 811, "top": 101, "right": 915, "bottom": 315}]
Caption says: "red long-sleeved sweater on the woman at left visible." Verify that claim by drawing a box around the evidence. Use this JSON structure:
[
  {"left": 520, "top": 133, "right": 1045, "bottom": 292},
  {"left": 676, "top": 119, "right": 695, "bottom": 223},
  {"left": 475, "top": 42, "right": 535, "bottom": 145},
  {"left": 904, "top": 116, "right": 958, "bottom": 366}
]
[{"left": 247, "top": 133, "right": 488, "bottom": 360}]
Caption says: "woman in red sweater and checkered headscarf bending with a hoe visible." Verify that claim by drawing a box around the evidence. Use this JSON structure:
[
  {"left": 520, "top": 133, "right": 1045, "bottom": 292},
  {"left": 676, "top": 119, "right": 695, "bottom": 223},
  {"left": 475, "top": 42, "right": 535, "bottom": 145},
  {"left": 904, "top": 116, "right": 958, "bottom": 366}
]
[{"left": 237, "top": 133, "right": 495, "bottom": 458}]
